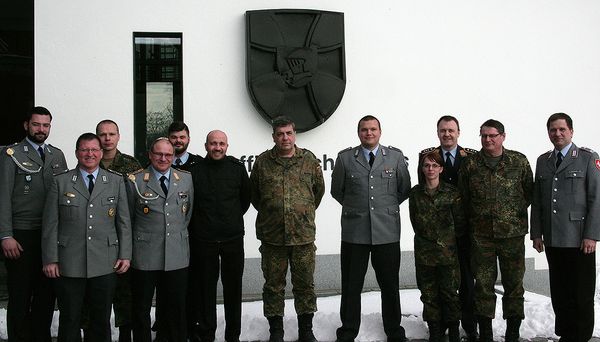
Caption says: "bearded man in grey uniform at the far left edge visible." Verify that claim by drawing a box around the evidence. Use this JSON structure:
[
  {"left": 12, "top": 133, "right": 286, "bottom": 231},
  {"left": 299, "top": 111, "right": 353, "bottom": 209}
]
[{"left": 0, "top": 107, "right": 67, "bottom": 341}]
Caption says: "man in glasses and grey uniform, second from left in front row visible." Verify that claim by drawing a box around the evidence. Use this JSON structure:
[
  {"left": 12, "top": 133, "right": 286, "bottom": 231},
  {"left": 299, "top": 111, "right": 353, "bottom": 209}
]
[{"left": 42, "top": 133, "right": 131, "bottom": 342}]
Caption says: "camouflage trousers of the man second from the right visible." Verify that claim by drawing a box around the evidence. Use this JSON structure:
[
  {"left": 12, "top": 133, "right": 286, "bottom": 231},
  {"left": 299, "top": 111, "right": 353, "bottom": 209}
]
[{"left": 471, "top": 236, "right": 525, "bottom": 319}]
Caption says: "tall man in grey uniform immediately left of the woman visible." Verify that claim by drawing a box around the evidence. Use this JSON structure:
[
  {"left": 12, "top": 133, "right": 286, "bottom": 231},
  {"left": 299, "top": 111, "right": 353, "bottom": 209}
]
[{"left": 331, "top": 115, "right": 410, "bottom": 342}]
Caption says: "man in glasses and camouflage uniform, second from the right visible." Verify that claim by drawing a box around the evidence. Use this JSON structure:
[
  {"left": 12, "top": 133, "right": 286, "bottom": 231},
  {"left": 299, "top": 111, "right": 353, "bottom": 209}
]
[{"left": 459, "top": 119, "right": 533, "bottom": 342}]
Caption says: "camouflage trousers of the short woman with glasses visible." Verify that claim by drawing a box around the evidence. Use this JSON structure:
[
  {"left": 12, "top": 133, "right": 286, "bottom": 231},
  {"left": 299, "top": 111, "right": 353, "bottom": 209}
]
[{"left": 415, "top": 260, "right": 461, "bottom": 322}]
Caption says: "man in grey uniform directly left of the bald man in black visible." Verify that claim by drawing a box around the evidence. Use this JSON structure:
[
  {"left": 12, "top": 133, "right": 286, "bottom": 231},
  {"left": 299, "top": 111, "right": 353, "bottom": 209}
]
[{"left": 129, "top": 138, "right": 194, "bottom": 342}]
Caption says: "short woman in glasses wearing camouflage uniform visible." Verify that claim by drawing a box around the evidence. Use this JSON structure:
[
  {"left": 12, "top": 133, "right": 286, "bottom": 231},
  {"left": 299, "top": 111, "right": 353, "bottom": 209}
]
[{"left": 409, "top": 152, "right": 466, "bottom": 342}]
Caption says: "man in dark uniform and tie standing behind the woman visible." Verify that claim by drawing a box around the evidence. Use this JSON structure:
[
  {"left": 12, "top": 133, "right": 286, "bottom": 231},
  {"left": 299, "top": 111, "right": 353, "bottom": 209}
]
[{"left": 417, "top": 115, "right": 478, "bottom": 342}]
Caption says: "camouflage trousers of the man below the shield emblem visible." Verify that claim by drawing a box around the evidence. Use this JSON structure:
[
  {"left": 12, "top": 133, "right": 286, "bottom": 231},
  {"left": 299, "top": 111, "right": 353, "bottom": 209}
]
[{"left": 259, "top": 243, "right": 317, "bottom": 317}]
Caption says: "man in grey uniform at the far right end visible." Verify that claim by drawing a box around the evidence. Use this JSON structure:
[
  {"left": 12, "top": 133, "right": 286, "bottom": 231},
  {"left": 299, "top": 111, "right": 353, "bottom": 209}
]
[{"left": 530, "top": 113, "right": 600, "bottom": 341}]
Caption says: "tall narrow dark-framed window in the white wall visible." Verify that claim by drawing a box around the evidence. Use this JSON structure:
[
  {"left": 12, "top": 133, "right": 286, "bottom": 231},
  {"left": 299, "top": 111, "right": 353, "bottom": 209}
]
[{"left": 133, "top": 32, "right": 183, "bottom": 165}]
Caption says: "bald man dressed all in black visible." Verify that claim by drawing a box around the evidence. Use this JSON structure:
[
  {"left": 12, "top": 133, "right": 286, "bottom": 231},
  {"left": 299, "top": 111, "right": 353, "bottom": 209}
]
[{"left": 188, "top": 130, "right": 250, "bottom": 342}]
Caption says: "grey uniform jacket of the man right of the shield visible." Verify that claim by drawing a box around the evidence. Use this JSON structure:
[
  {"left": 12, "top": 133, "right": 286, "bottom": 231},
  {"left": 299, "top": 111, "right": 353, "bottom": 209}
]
[{"left": 331, "top": 145, "right": 410, "bottom": 245}]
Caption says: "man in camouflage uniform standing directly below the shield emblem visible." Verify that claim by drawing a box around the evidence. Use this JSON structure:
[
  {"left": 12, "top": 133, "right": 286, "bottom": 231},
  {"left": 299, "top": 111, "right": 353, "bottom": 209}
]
[{"left": 250, "top": 117, "right": 325, "bottom": 342}]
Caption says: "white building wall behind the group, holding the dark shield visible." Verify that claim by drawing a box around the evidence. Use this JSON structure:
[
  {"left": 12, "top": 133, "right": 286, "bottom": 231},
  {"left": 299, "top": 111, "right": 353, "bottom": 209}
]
[{"left": 35, "top": 0, "right": 600, "bottom": 264}]
